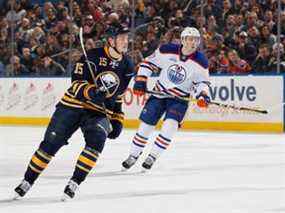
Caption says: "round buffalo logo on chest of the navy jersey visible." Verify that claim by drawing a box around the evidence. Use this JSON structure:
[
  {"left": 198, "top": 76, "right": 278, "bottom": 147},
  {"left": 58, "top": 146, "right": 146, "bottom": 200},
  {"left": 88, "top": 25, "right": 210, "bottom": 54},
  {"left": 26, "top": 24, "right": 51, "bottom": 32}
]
[{"left": 96, "top": 71, "right": 120, "bottom": 98}]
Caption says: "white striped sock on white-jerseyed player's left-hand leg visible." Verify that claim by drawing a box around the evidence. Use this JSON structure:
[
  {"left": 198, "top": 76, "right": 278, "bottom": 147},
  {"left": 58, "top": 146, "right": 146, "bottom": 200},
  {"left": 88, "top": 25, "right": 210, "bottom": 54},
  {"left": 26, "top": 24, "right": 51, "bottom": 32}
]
[{"left": 130, "top": 122, "right": 155, "bottom": 158}]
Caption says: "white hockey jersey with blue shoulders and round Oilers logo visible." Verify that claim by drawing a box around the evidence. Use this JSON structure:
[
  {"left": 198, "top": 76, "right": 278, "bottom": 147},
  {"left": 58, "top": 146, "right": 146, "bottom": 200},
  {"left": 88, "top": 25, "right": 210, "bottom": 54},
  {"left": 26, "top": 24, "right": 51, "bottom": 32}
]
[{"left": 138, "top": 44, "right": 210, "bottom": 100}]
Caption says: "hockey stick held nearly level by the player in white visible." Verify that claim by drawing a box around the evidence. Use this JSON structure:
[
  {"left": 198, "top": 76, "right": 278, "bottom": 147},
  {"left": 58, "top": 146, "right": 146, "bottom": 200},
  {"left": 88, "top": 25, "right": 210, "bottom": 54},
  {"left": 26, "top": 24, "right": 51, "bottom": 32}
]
[{"left": 146, "top": 91, "right": 268, "bottom": 114}]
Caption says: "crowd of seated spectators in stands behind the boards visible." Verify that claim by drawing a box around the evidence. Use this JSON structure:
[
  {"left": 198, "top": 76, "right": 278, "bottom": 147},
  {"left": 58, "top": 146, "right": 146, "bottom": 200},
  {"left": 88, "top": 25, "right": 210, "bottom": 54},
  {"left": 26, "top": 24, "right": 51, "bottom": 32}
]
[{"left": 0, "top": 0, "right": 285, "bottom": 77}]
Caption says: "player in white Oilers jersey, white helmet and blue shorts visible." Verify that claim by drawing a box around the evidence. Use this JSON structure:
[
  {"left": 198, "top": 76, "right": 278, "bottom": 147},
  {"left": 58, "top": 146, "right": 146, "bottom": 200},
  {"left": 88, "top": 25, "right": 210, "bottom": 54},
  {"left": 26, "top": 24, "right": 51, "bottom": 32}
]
[{"left": 122, "top": 27, "right": 210, "bottom": 170}]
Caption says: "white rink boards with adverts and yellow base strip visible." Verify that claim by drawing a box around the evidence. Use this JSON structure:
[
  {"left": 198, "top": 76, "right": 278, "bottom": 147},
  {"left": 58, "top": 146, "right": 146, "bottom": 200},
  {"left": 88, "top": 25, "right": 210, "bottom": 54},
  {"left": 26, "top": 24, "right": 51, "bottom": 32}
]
[{"left": 0, "top": 76, "right": 284, "bottom": 132}]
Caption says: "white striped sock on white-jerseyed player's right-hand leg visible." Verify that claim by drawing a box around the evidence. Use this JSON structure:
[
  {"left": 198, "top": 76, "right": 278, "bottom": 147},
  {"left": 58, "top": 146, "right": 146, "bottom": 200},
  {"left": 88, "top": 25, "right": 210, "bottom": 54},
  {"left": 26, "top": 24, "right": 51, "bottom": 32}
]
[{"left": 150, "top": 119, "right": 178, "bottom": 158}]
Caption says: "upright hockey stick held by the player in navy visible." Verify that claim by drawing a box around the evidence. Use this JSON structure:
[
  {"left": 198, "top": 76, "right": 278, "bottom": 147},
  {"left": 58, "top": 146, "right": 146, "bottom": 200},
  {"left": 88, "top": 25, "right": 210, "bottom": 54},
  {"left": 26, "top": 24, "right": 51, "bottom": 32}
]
[{"left": 79, "top": 27, "right": 113, "bottom": 132}]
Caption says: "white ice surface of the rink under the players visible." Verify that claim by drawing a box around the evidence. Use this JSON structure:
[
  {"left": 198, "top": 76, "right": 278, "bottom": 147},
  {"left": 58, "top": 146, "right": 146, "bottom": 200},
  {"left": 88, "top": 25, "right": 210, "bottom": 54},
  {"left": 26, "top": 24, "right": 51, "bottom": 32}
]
[{"left": 0, "top": 127, "right": 285, "bottom": 213}]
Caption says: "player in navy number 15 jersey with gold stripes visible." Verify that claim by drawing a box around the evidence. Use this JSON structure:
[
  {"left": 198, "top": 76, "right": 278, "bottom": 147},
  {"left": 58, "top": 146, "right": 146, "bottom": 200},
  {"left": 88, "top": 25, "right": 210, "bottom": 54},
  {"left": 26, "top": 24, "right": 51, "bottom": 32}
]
[{"left": 15, "top": 24, "right": 134, "bottom": 200}]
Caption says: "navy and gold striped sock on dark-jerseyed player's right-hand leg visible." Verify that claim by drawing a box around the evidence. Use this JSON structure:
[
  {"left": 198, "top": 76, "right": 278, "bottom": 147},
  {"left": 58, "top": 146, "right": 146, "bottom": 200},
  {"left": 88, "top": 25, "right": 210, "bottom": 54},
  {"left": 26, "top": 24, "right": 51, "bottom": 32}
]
[{"left": 71, "top": 147, "right": 99, "bottom": 185}]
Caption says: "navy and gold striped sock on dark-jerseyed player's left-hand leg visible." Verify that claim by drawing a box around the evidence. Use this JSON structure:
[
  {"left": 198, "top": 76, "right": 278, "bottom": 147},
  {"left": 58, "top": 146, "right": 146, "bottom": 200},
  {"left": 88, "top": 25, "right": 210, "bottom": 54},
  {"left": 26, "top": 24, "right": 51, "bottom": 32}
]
[{"left": 25, "top": 149, "right": 52, "bottom": 185}]
